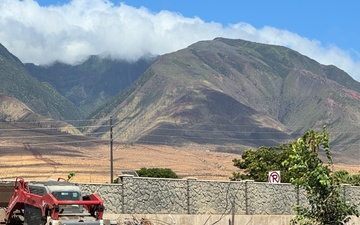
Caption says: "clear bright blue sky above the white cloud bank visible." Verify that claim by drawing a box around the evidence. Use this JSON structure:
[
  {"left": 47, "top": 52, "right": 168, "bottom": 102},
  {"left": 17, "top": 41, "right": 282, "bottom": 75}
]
[{"left": 131, "top": 0, "right": 360, "bottom": 52}]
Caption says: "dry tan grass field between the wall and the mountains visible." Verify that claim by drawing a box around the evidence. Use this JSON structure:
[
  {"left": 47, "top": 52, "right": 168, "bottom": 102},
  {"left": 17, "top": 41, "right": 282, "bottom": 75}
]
[{"left": 0, "top": 136, "right": 360, "bottom": 183}]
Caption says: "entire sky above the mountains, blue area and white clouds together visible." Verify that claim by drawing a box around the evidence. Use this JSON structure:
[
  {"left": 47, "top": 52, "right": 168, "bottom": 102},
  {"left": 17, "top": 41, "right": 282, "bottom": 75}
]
[{"left": 0, "top": 0, "right": 360, "bottom": 80}]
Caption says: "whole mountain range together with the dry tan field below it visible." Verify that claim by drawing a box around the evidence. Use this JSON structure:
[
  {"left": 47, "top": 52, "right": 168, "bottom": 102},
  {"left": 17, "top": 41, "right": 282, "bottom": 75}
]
[{"left": 0, "top": 38, "right": 360, "bottom": 182}]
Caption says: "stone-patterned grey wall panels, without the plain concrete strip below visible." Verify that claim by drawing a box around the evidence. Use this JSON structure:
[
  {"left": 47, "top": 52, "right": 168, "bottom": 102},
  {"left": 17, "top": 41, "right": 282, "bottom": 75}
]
[{"left": 79, "top": 176, "right": 360, "bottom": 215}]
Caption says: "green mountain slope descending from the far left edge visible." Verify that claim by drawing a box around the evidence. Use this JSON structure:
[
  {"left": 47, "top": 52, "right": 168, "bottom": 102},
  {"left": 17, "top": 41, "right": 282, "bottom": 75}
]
[{"left": 0, "top": 44, "right": 80, "bottom": 119}]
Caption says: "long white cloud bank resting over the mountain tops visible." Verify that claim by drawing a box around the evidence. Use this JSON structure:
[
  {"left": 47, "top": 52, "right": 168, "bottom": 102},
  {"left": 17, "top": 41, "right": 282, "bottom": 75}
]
[{"left": 0, "top": 0, "right": 360, "bottom": 80}]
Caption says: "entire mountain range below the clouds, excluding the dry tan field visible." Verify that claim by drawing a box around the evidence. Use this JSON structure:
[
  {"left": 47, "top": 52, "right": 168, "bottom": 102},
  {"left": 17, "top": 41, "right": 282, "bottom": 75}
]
[{"left": 0, "top": 38, "right": 360, "bottom": 160}]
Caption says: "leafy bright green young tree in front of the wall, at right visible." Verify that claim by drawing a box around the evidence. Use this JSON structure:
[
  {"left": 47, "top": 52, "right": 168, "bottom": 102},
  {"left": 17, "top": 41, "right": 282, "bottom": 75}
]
[{"left": 283, "top": 127, "right": 360, "bottom": 225}]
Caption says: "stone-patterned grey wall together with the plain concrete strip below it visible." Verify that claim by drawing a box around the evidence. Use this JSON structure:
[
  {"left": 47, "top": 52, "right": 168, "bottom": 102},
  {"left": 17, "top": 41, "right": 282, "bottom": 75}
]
[{"left": 0, "top": 176, "right": 360, "bottom": 225}]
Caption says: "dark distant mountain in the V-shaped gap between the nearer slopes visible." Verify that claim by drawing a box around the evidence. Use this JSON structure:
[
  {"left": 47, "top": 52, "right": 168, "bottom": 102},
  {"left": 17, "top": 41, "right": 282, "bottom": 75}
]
[{"left": 25, "top": 56, "right": 155, "bottom": 117}]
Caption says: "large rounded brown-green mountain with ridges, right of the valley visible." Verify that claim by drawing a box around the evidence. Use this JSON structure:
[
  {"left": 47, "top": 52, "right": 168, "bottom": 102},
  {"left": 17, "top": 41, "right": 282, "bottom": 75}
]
[{"left": 87, "top": 38, "right": 360, "bottom": 159}]
